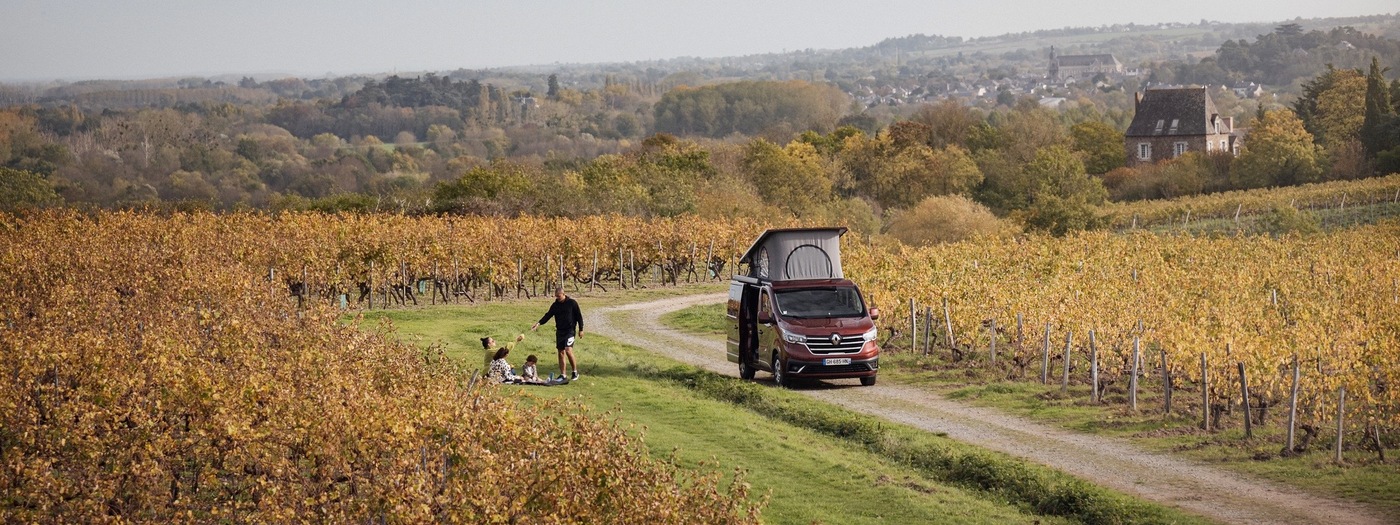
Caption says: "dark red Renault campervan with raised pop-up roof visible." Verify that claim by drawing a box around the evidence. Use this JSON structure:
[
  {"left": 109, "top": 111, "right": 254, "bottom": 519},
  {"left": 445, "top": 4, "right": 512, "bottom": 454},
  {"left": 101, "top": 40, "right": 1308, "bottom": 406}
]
[{"left": 727, "top": 228, "right": 879, "bottom": 386}]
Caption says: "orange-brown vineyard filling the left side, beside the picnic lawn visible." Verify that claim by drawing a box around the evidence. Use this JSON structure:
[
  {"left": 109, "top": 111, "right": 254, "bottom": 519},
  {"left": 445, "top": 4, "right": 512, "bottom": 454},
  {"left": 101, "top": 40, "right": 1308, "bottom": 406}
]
[{"left": 0, "top": 213, "right": 757, "bottom": 524}]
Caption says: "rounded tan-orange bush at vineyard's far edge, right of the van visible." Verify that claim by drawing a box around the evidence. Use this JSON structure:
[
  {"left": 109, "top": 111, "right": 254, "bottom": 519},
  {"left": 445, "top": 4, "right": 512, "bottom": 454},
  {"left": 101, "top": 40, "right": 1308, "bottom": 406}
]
[{"left": 888, "top": 195, "right": 1008, "bottom": 246}]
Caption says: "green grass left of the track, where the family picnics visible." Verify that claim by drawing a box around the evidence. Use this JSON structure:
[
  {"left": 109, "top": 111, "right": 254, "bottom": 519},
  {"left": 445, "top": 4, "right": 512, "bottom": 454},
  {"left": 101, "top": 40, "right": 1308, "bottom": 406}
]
[{"left": 358, "top": 290, "right": 1194, "bottom": 524}]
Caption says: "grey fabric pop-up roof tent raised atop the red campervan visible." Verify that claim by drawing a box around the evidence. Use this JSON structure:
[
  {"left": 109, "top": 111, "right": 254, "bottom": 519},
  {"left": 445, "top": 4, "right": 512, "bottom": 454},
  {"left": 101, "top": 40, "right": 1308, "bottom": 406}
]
[{"left": 739, "top": 227, "right": 846, "bottom": 281}]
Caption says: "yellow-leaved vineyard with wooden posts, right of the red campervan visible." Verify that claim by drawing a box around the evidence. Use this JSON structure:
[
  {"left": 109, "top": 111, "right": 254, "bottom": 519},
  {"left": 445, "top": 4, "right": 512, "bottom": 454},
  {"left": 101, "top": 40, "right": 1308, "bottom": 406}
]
[{"left": 846, "top": 223, "right": 1400, "bottom": 453}]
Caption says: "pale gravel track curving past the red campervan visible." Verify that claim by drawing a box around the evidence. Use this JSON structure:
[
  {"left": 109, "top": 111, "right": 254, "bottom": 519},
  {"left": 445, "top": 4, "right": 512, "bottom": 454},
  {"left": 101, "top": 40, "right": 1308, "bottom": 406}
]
[{"left": 588, "top": 294, "right": 1400, "bottom": 525}]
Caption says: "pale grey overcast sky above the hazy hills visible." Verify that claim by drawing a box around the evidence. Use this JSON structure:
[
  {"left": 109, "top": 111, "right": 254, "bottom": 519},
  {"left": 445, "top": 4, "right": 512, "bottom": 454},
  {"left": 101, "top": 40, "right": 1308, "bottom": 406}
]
[{"left": 0, "top": 0, "right": 1397, "bottom": 81}]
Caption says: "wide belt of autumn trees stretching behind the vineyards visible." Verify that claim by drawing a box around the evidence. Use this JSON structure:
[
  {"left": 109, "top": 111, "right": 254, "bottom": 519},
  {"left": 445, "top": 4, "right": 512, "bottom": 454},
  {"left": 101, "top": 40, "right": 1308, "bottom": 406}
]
[{"left": 8, "top": 59, "right": 1400, "bottom": 245}]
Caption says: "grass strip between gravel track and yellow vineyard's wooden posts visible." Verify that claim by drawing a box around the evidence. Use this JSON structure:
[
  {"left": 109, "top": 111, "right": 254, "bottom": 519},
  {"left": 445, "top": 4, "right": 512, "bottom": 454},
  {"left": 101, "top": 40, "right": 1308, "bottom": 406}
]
[{"left": 662, "top": 305, "right": 1400, "bottom": 514}]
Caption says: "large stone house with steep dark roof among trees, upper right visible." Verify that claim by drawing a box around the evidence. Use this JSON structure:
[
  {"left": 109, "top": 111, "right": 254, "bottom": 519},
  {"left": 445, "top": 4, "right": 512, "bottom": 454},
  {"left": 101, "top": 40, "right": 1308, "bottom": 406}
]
[{"left": 1123, "top": 87, "right": 1240, "bottom": 167}]
